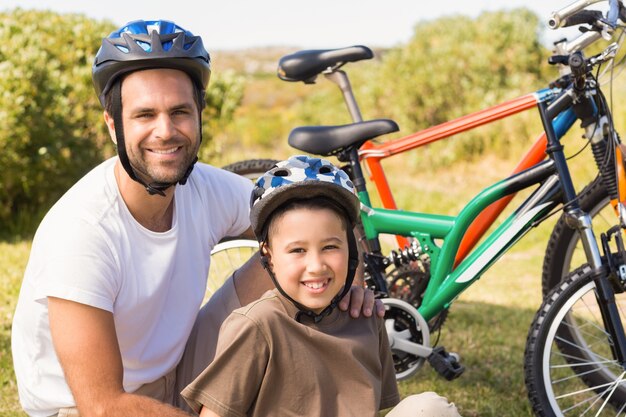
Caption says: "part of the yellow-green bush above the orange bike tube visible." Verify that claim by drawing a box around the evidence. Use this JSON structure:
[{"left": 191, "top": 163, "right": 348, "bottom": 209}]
[{"left": 370, "top": 9, "right": 546, "bottom": 130}]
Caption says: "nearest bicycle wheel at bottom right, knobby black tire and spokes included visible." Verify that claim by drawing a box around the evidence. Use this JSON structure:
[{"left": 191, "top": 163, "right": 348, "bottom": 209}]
[{"left": 524, "top": 265, "right": 626, "bottom": 417}]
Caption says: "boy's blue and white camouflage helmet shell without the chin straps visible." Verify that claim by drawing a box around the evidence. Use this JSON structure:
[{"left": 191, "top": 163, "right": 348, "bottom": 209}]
[{"left": 250, "top": 155, "right": 360, "bottom": 239}]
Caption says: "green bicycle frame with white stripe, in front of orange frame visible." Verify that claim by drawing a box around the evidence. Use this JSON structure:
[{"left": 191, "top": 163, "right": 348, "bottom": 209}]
[{"left": 359, "top": 110, "right": 576, "bottom": 321}]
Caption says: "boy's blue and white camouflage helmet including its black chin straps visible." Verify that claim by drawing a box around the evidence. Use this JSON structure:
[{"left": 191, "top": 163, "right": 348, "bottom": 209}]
[{"left": 250, "top": 155, "right": 360, "bottom": 322}]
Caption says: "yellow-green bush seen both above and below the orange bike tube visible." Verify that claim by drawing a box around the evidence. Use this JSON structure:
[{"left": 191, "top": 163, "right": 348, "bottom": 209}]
[{"left": 360, "top": 9, "right": 549, "bottom": 165}]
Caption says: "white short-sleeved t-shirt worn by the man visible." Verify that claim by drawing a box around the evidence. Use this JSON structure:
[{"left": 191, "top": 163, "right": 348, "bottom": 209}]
[{"left": 12, "top": 158, "right": 252, "bottom": 417}]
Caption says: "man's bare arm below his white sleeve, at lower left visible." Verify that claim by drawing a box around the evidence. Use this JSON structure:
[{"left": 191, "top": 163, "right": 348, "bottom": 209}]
[{"left": 48, "top": 297, "right": 189, "bottom": 417}]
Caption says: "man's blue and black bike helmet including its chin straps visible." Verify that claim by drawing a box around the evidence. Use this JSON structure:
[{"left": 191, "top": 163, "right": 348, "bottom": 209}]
[{"left": 92, "top": 20, "right": 211, "bottom": 195}]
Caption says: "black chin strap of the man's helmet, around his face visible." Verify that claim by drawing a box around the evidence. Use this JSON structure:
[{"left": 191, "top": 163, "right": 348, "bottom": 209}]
[{"left": 111, "top": 79, "right": 197, "bottom": 197}]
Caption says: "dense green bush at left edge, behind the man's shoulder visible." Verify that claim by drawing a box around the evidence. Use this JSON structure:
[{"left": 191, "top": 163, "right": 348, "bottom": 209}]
[{"left": 0, "top": 9, "right": 112, "bottom": 234}]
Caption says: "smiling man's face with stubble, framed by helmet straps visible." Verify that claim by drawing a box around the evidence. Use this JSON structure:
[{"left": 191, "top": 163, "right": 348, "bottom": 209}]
[{"left": 108, "top": 69, "right": 200, "bottom": 183}]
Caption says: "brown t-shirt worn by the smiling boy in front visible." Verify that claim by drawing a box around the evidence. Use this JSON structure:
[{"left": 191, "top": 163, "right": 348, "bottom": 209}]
[{"left": 182, "top": 290, "right": 400, "bottom": 417}]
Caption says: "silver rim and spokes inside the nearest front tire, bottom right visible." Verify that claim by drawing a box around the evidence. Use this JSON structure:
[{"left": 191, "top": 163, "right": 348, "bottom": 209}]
[{"left": 541, "top": 274, "right": 626, "bottom": 416}]
